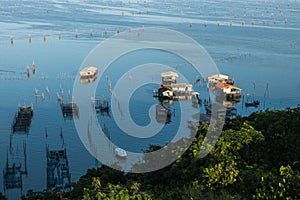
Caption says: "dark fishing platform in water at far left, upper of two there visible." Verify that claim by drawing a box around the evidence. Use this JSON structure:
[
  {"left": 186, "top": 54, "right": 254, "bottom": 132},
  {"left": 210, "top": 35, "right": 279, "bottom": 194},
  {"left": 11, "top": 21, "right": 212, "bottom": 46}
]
[{"left": 11, "top": 104, "right": 33, "bottom": 133}]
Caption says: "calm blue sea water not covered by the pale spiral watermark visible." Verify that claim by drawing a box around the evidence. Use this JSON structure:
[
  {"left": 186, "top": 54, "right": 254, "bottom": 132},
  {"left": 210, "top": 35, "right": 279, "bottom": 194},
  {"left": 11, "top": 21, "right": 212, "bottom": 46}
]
[{"left": 0, "top": 1, "right": 300, "bottom": 199}]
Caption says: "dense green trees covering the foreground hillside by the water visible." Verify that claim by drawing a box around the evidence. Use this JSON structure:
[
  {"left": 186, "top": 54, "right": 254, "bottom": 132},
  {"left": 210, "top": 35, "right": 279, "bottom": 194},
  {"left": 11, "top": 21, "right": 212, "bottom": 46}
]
[{"left": 2, "top": 108, "right": 300, "bottom": 200}]
